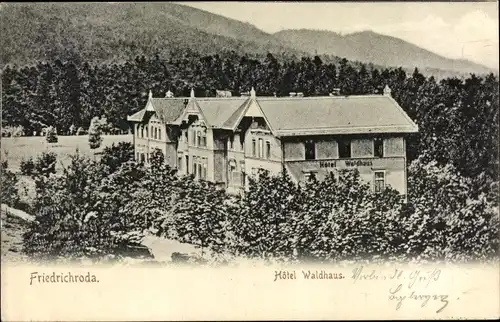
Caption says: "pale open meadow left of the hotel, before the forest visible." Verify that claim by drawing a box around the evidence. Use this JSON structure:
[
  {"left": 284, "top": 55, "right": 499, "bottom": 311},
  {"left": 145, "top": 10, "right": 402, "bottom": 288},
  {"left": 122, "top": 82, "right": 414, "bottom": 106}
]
[{"left": 1, "top": 134, "right": 132, "bottom": 170}]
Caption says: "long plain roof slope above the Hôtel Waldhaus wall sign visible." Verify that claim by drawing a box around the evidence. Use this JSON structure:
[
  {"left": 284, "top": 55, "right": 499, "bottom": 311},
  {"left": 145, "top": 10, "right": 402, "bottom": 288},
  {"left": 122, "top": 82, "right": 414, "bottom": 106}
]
[{"left": 257, "top": 95, "right": 418, "bottom": 136}]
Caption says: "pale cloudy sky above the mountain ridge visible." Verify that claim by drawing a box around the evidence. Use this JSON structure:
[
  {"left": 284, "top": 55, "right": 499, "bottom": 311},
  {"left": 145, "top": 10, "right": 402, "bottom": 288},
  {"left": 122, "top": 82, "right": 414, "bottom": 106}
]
[{"left": 184, "top": 1, "right": 499, "bottom": 69}]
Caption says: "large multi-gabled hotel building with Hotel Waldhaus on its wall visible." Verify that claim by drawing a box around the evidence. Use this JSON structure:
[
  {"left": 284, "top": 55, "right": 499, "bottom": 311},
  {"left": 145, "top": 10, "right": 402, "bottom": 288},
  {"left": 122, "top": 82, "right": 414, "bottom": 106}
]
[{"left": 128, "top": 86, "right": 418, "bottom": 194}]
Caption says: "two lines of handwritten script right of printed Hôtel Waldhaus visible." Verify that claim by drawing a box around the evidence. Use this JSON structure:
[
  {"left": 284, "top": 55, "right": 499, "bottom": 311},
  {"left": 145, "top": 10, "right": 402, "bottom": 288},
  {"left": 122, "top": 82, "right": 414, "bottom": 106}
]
[{"left": 351, "top": 266, "right": 449, "bottom": 313}]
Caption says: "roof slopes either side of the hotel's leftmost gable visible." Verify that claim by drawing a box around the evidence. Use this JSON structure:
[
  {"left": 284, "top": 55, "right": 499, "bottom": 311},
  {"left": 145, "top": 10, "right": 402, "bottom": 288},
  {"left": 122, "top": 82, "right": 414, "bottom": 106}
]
[{"left": 127, "top": 97, "right": 187, "bottom": 123}]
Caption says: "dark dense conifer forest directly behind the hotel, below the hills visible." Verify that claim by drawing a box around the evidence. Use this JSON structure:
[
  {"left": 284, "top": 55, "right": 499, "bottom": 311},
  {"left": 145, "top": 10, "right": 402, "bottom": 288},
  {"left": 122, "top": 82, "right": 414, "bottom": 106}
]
[{"left": 2, "top": 50, "right": 499, "bottom": 180}]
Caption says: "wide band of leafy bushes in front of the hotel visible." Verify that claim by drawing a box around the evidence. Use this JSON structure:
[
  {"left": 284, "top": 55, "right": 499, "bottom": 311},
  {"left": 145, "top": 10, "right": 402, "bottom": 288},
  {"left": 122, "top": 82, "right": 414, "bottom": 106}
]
[{"left": 18, "top": 148, "right": 499, "bottom": 262}]
